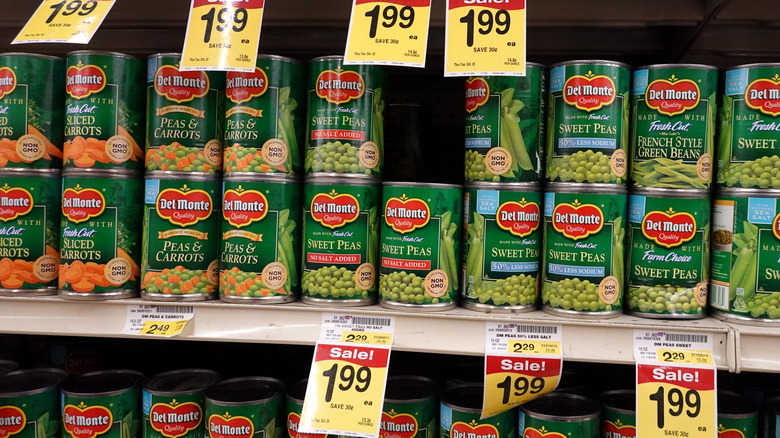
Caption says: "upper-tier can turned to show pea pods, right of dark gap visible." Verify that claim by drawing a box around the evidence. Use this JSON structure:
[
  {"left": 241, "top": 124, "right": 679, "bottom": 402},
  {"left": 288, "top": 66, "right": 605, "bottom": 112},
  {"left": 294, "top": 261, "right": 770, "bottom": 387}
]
[{"left": 465, "top": 63, "right": 546, "bottom": 182}]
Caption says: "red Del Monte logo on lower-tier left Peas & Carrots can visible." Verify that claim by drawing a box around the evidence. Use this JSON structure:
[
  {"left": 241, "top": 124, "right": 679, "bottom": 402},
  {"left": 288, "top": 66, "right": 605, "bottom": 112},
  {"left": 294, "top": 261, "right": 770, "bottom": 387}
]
[{"left": 156, "top": 184, "right": 213, "bottom": 227}]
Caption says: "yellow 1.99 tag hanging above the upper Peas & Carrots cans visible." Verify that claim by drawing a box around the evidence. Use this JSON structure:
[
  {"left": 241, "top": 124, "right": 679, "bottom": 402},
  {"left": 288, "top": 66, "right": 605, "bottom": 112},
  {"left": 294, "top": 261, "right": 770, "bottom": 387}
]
[{"left": 181, "top": 0, "right": 264, "bottom": 72}]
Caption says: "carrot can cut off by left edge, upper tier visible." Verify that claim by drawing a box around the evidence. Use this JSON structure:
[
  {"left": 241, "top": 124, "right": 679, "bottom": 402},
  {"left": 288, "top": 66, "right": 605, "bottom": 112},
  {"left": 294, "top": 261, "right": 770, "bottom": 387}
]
[{"left": 0, "top": 53, "right": 65, "bottom": 170}]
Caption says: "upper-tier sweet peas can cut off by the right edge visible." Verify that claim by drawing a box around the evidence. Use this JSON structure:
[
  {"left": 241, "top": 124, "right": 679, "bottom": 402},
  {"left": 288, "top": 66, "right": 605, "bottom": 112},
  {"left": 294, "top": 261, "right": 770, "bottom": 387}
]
[{"left": 717, "top": 64, "right": 780, "bottom": 189}]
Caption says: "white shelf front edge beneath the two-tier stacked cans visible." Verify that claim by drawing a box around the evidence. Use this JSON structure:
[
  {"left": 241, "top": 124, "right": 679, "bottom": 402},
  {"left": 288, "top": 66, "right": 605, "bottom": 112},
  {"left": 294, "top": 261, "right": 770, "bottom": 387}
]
[{"left": 0, "top": 297, "right": 736, "bottom": 371}]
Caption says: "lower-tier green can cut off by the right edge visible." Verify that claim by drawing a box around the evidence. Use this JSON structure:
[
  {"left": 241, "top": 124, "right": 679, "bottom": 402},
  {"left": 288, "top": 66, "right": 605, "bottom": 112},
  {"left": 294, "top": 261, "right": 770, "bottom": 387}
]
[{"left": 709, "top": 189, "right": 780, "bottom": 325}]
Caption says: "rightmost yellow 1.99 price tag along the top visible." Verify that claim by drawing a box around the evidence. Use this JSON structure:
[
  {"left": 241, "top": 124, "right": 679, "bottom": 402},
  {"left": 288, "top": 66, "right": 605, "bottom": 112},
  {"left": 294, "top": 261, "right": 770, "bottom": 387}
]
[{"left": 444, "top": 0, "right": 526, "bottom": 76}]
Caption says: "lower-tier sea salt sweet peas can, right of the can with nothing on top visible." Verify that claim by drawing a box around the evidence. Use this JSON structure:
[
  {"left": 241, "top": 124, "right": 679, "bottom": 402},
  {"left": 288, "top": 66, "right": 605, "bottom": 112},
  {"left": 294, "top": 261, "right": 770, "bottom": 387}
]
[{"left": 463, "top": 183, "right": 543, "bottom": 312}]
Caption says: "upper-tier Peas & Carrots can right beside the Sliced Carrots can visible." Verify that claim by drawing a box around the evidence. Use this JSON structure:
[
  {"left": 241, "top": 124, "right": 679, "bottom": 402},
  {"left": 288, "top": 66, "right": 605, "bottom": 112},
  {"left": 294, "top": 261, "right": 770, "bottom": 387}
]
[{"left": 145, "top": 53, "right": 225, "bottom": 173}]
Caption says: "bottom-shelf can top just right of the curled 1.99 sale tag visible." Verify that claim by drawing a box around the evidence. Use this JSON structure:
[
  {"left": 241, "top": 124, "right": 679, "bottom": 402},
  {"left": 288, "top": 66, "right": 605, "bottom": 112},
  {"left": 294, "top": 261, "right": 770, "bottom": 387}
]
[{"left": 517, "top": 392, "right": 601, "bottom": 438}]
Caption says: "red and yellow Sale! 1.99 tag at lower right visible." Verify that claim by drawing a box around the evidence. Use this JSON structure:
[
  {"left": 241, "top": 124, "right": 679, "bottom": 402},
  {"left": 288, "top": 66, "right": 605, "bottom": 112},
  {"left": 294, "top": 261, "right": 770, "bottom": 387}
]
[{"left": 636, "top": 364, "right": 717, "bottom": 438}]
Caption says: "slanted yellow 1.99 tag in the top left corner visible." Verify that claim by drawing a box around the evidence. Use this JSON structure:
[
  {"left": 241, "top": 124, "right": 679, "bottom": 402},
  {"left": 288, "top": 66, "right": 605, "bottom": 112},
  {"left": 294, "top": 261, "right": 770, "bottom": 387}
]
[{"left": 11, "top": 0, "right": 114, "bottom": 44}]
